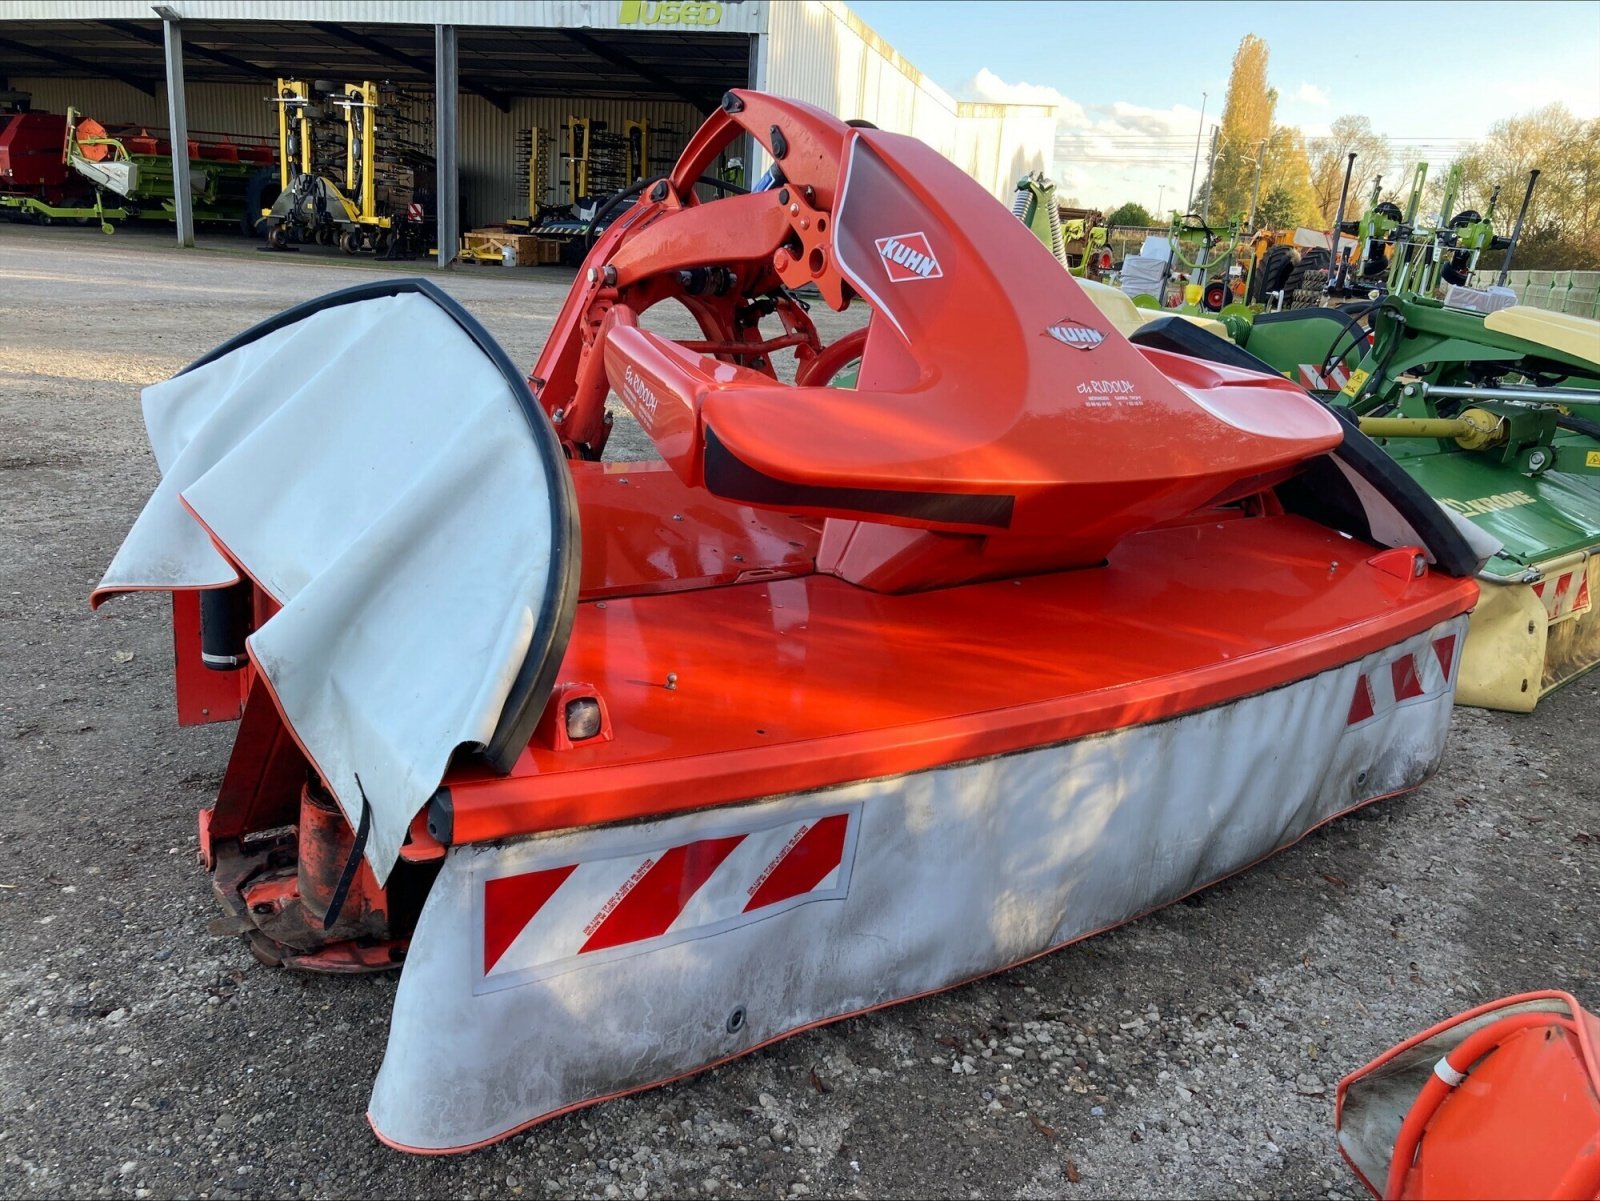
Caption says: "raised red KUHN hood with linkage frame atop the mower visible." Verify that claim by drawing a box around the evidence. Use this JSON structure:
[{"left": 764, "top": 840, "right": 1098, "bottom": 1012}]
[{"left": 534, "top": 93, "right": 1342, "bottom": 589}]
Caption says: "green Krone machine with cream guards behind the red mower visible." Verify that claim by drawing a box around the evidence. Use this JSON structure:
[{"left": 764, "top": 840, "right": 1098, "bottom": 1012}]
[{"left": 1024, "top": 171, "right": 1600, "bottom": 712}]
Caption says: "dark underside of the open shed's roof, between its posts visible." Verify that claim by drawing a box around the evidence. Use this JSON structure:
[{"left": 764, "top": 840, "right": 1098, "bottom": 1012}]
[{"left": 0, "top": 17, "right": 750, "bottom": 110}]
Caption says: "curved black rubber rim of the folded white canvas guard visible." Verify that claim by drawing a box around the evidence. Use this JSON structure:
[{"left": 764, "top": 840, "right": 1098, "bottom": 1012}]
[{"left": 178, "top": 277, "right": 581, "bottom": 776}]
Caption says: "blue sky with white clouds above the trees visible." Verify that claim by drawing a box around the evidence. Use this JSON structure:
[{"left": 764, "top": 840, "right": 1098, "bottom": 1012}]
[{"left": 846, "top": 0, "right": 1600, "bottom": 208}]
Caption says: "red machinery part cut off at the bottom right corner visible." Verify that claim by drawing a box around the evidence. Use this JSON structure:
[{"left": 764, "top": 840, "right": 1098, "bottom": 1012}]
[{"left": 1334, "top": 992, "right": 1600, "bottom": 1201}]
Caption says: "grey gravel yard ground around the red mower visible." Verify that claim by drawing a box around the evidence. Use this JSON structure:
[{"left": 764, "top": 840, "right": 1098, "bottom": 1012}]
[{"left": 0, "top": 225, "right": 1600, "bottom": 1198}]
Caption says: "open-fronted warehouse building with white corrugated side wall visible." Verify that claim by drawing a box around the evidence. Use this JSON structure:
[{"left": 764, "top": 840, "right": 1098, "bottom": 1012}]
[{"left": 0, "top": 0, "right": 1054, "bottom": 257}]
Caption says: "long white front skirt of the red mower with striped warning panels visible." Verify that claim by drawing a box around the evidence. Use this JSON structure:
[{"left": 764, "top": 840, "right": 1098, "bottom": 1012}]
[{"left": 368, "top": 617, "right": 1467, "bottom": 1151}]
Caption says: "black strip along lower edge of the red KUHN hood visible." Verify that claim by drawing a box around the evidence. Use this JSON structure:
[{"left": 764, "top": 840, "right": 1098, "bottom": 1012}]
[{"left": 704, "top": 425, "right": 1016, "bottom": 529}]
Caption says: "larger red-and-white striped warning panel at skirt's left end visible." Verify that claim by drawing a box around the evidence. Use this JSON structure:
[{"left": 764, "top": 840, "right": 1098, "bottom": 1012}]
[{"left": 482, "top": 809, "right": 856, "bottom": 977}]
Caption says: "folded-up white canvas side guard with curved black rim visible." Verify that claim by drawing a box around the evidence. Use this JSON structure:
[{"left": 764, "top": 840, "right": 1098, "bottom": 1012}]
[{"left": 93, "top": 280, "right": 578, "bottom": 883}]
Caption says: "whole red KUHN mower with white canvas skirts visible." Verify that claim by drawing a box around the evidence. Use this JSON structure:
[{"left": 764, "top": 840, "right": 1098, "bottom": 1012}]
[{"left": 96, "top": 91, "right": 1480, "bottom": 1151}]
